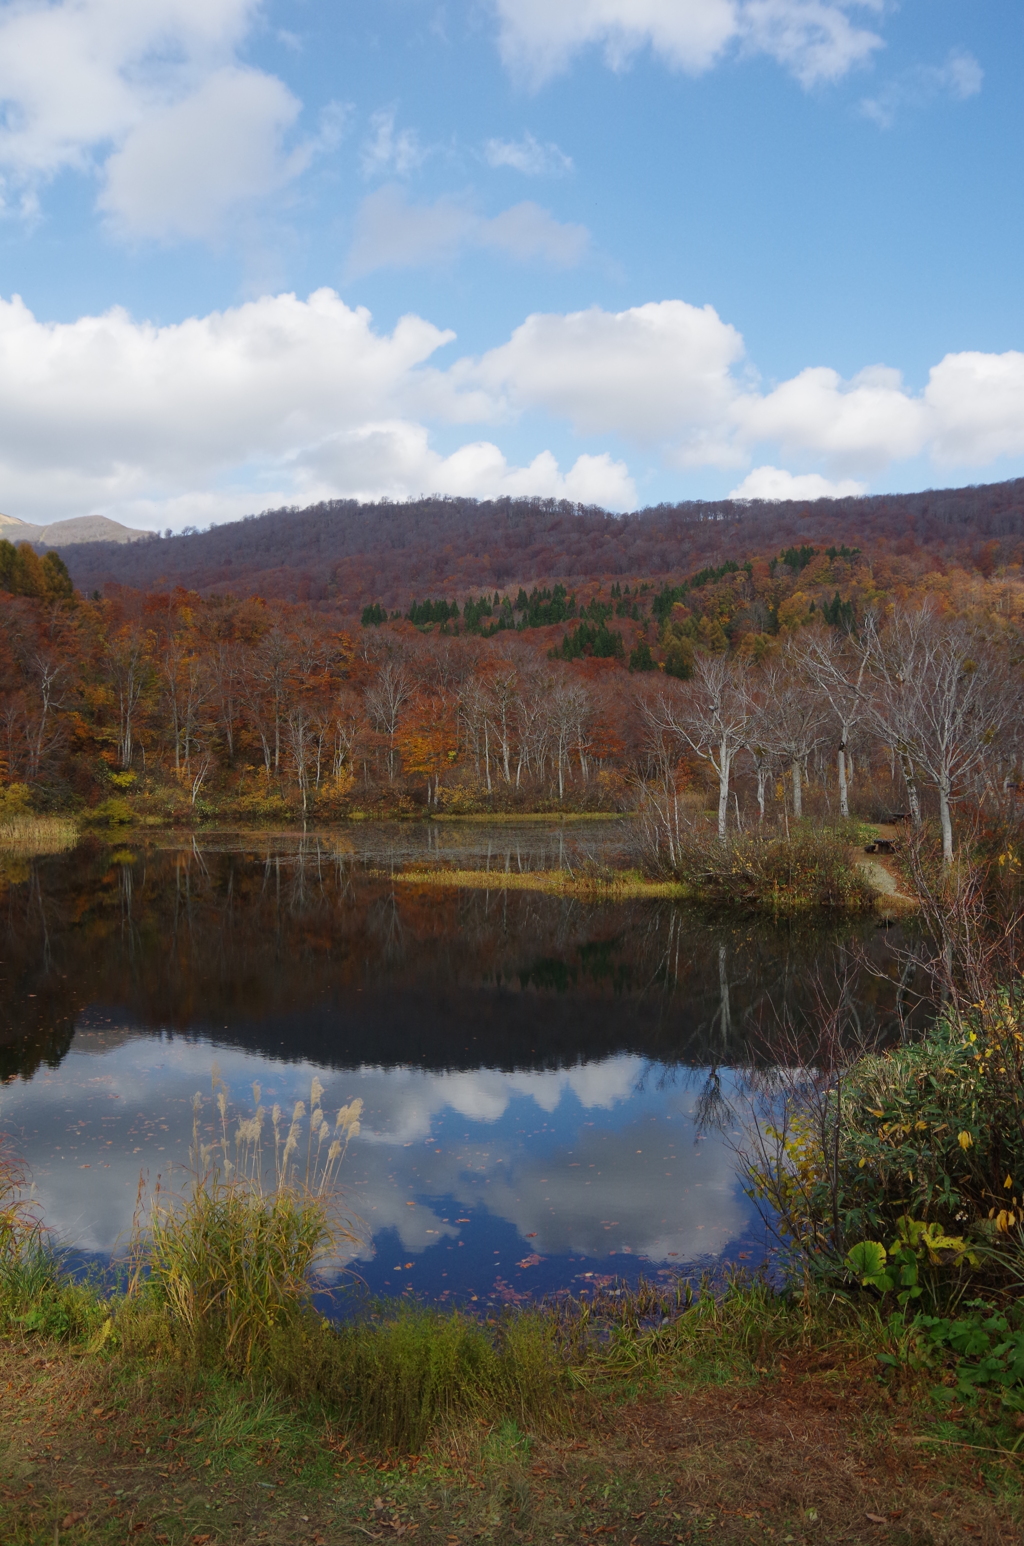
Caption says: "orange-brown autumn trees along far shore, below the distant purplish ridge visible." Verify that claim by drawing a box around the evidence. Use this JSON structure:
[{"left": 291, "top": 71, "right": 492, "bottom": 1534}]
[{"left": 0, "top": 525, "right": 1024, "bottom": 869}]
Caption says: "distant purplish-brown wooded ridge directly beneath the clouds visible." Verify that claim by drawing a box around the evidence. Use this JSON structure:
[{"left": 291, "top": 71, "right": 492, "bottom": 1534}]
[{"left": 60, "top": 478, "right": 1024, "bottom": 615}]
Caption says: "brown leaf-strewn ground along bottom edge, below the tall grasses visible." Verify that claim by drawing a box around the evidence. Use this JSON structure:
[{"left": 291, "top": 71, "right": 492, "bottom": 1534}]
[{"left": 0, "top": 1340, "right": 1024, "bottom": 1546}]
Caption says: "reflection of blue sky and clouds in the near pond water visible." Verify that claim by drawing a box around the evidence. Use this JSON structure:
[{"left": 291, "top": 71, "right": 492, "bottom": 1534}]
[{"left": 0, "top": 1028, "right": 750, "bottom": 1291}]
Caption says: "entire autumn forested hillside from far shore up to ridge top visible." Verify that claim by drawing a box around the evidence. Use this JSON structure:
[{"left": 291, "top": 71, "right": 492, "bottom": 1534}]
[{"left": 0, "top": 481, "right": 1024, "bottom": 852}]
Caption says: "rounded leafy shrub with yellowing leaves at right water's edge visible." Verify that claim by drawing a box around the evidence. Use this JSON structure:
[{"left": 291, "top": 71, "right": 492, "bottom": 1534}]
[{"left": 750, "top": 983, "right": 1024, "bottom": 1308}]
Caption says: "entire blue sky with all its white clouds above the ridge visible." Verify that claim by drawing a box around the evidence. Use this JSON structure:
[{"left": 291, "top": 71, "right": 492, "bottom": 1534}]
[{"left": 0, "top": 0, "right": 1024, "bottom": 529}]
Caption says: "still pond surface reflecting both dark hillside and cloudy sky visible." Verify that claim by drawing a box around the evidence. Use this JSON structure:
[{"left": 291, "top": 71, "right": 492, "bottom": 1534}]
[{"left": 0, "top": 822, "right": 921, "bottom": 1302}]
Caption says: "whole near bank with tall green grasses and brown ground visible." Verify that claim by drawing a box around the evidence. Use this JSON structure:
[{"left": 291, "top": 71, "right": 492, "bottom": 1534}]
[{"left": 0, "top": 1235, "right": 1024, "bottom": 1546}]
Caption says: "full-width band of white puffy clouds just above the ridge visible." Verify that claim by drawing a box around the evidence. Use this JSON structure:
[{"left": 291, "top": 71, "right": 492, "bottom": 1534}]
[{"left": 0, "top": 289, "right": 1024, "bottom": 527}]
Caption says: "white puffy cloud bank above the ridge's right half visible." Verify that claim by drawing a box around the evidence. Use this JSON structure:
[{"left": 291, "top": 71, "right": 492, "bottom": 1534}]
[{"left": 442, "top": 300, "right": 1024, "bottom": 485}]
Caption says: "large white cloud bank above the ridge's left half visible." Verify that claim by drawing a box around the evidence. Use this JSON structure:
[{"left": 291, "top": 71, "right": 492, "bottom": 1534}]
[{"left": 0, "top": 289, "right": 636, "bottom": 527}]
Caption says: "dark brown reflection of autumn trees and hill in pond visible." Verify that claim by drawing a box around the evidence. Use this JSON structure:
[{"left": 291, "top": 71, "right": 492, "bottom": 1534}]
[{"left": 0, "top": 835, "right": 919, "bottom": 1099}]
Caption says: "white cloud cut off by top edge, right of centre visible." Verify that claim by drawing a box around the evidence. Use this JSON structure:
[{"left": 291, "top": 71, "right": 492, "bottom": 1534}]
[{"left": 495, "top": 0, "right": 882, "bottom": 87}]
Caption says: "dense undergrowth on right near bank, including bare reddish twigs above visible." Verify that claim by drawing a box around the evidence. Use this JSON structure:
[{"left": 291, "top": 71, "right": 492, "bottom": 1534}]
[{"left": 733, "top": 829, "right": 1024, "bottom": 1449}]
